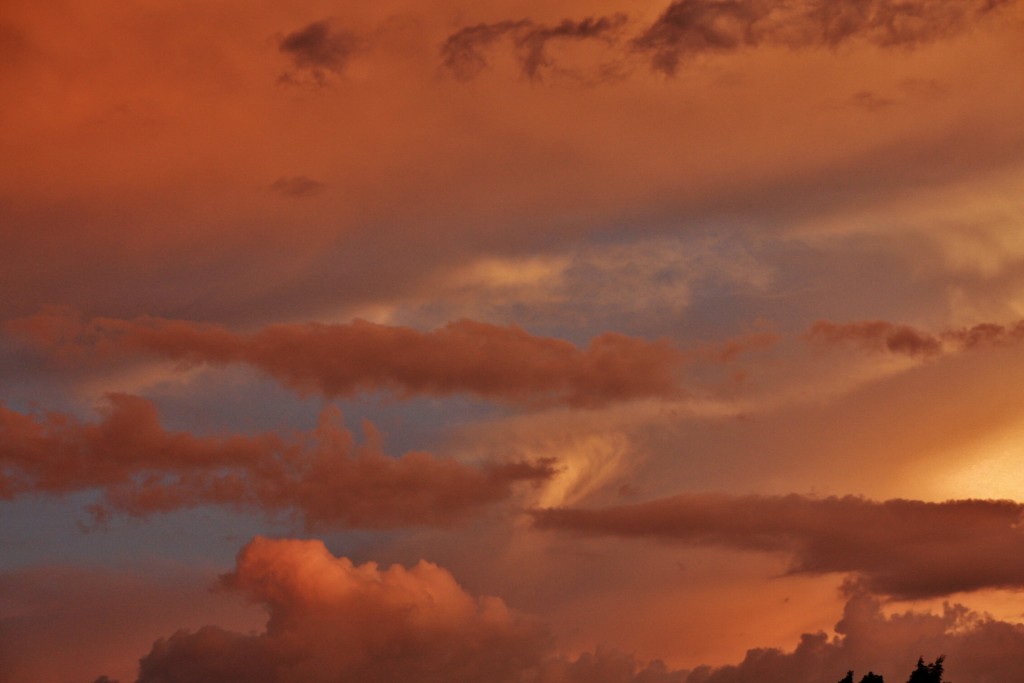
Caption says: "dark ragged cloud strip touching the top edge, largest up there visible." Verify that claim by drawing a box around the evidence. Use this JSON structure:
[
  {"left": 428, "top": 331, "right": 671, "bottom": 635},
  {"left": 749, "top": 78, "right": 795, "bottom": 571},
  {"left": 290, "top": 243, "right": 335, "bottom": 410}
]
[{"left": 633, "top": 0, "right": 1015, "bottom": 75}]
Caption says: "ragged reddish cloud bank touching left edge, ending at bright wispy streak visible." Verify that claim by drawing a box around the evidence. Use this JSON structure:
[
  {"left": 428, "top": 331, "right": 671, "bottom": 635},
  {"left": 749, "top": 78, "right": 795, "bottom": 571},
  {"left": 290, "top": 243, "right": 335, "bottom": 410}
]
[{"left": 0, "top": 394, "right": 555, "bottom": 528}]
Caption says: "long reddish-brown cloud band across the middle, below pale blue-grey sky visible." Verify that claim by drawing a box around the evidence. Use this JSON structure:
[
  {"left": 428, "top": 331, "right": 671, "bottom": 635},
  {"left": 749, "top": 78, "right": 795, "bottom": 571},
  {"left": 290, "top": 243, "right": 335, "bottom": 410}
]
[{"left": 6, "top": 311, "right": 684, "bottom": 408}]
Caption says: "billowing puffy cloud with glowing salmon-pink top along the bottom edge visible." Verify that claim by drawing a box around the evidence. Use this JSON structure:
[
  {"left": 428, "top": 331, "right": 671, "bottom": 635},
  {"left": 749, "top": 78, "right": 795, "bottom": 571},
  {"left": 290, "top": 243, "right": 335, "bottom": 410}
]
[{"left": 138, "top": 538, "right": 548, "bottom": 683}]
